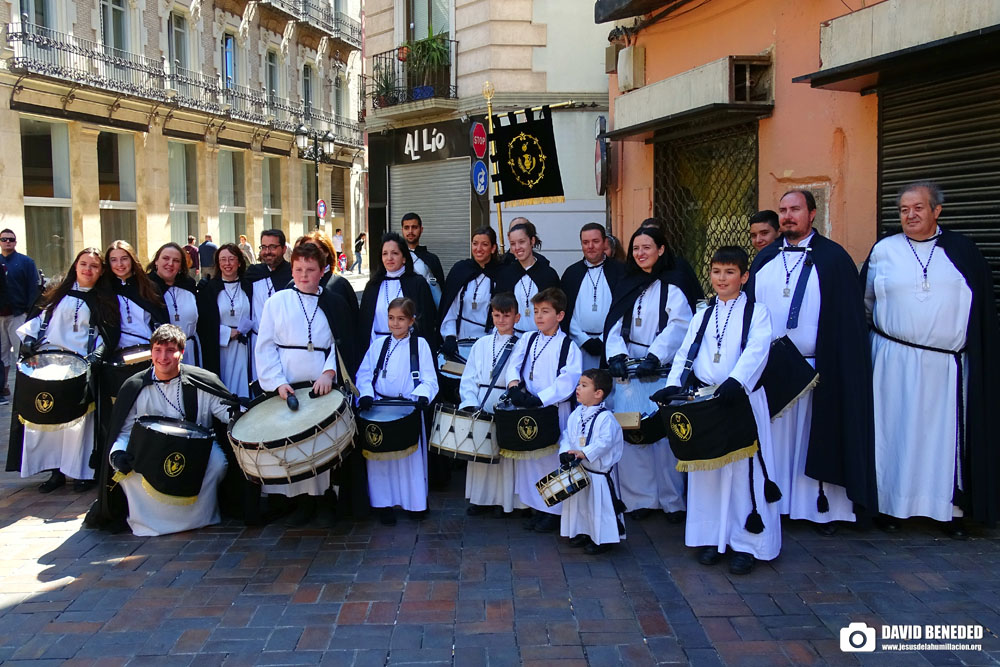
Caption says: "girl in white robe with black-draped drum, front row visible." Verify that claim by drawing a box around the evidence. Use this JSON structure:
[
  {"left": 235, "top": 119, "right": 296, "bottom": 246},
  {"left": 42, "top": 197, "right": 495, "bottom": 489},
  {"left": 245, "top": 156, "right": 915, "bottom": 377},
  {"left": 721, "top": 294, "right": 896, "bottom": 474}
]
[{"left": 357, "top": 297, "right": 438, "bottom": 526}]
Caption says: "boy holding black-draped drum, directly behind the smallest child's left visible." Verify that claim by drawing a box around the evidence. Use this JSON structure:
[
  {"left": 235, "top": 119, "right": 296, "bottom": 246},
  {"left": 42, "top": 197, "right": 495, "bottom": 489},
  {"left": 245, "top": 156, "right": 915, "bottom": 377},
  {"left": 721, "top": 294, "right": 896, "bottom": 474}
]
[{"left": 500, "top": 287, "right": 583, "bottom": 533}]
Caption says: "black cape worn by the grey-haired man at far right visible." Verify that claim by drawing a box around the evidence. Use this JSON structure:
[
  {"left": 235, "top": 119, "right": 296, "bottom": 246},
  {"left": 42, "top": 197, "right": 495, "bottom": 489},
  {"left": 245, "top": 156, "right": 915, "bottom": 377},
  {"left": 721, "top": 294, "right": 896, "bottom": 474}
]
[{"left": 860, "top": 229, "right": 1000, "bottom": 527}]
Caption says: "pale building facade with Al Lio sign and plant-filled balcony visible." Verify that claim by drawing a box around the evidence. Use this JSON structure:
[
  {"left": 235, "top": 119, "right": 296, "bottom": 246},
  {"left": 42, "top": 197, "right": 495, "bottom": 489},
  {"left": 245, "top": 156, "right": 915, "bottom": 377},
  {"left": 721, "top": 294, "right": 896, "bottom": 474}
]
[{"left": 365, "top": 0, "right": 608, "bottom": 271}]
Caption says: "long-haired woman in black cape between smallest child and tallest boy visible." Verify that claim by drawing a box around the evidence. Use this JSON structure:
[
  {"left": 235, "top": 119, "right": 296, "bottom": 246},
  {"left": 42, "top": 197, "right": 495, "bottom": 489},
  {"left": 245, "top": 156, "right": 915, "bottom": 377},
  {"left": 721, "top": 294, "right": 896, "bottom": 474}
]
[{"left": 604, "top": 227, "right": 704, "bottom": 523}]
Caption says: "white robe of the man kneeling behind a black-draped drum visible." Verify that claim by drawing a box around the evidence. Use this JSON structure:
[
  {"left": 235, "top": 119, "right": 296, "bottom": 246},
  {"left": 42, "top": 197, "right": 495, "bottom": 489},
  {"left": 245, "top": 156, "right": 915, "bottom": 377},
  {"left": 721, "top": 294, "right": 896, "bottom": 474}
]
[{"left": 111, "top": 370, "right": 229, "bottom": 536}]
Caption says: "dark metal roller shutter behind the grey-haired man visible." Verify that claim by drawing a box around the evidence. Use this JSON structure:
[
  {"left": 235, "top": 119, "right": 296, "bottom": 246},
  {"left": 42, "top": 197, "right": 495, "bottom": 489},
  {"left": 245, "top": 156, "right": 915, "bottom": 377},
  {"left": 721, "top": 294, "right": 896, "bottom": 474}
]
[{"left": 879, "top": 69, "right": 1000, "bottom": 300}]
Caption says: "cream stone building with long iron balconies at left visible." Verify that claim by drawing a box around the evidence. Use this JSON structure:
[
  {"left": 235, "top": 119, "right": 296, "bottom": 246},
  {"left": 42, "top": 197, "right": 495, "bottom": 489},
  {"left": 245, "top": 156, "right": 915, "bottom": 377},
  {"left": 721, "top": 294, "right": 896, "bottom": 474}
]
[{"left": 0, "top": 0, "right": 365, "bottom": 276}]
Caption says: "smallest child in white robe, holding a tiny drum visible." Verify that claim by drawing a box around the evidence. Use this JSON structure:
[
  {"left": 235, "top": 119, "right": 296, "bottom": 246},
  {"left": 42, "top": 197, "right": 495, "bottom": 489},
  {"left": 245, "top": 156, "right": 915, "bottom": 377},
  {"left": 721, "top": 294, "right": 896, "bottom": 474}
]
[{"left": 559, "top": 368, "right": 625, "bottom": 554}]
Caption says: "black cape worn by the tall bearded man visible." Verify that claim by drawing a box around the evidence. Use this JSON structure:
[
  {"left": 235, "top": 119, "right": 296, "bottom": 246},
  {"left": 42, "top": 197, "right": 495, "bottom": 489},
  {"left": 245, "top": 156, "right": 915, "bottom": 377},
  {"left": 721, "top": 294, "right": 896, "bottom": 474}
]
[{"left": 745, "top": 233, "right": 878, "bottom": 514}]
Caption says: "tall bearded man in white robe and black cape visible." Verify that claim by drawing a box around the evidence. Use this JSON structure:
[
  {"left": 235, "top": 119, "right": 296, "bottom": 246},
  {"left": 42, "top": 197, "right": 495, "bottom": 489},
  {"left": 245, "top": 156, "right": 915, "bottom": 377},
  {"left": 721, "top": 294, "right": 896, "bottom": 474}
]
[{"left": 746, "top": 190, "right": 878, "bottom": 535}]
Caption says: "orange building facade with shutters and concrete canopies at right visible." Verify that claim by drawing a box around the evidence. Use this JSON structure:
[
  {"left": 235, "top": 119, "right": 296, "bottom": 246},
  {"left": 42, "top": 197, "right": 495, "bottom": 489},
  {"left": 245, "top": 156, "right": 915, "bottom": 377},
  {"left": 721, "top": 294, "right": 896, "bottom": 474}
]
[{"left": 594, "top": 0, "right": 1000, "bottom": 290}]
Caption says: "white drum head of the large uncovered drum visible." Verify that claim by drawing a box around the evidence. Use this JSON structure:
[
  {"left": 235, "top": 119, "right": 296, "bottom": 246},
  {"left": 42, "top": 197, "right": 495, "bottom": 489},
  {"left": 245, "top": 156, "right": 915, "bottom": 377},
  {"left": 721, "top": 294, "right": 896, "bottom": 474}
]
[{"left": 230, "top": 387, "right": 345, "bottom": 443}]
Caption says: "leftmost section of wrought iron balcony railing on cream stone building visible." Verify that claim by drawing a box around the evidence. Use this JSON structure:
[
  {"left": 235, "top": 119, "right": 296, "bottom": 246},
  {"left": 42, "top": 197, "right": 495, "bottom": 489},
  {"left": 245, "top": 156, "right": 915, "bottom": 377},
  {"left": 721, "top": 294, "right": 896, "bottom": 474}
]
[{"left": 4, "top": 23, "right": 166, "bottom": 100}]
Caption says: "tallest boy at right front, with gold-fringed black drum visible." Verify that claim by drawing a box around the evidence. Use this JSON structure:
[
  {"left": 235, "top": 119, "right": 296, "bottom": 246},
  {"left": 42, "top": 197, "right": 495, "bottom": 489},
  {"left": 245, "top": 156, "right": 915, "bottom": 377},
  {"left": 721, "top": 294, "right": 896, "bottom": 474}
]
[{"left": 653, "top": 246, "right": 781, "bottom": 574}]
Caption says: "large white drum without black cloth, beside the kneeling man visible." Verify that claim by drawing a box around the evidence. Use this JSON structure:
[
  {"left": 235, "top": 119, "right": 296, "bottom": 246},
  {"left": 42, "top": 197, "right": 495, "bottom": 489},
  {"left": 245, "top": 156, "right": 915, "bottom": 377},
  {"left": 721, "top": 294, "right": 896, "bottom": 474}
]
[{"left": 228, "top": 382, "right": 357, "bottom": 484}]
